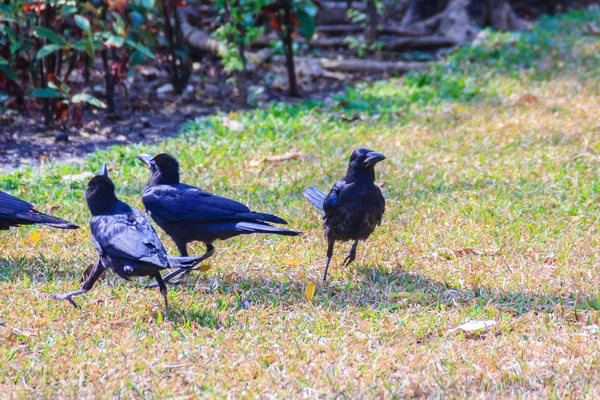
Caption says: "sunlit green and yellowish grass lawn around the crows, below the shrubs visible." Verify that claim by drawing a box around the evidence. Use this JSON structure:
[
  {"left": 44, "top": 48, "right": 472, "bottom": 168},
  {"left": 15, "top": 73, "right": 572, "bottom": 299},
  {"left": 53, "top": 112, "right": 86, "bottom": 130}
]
[{"left": 0, "top": 11, "right": 600, "bottom": 398}]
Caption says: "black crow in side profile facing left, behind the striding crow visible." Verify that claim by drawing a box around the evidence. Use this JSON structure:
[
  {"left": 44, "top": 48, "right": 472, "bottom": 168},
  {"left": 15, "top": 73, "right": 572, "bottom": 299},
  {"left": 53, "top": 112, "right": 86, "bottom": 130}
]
[{"left": 137, "top": 153, "right": 301, "bottom": 286}]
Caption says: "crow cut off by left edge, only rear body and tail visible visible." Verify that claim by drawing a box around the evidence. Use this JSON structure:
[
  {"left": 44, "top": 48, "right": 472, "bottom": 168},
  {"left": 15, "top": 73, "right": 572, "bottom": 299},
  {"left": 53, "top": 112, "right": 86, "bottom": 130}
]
[{"left": 0, "top": 192, "right": 79, "bottom": 231}]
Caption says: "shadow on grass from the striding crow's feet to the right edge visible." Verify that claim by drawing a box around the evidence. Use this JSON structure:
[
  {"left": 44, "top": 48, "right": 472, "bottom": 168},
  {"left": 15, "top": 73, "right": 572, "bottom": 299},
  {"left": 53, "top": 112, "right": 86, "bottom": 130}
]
[{"left": 158, "top": 265, "right": 600, "bottom": 329}]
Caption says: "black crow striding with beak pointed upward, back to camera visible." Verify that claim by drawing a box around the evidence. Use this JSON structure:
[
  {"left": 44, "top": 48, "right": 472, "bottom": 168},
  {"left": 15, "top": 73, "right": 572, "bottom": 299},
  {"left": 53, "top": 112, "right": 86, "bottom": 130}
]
[{"left": 54, "top": 164, "right": 201, "bottom": 308}]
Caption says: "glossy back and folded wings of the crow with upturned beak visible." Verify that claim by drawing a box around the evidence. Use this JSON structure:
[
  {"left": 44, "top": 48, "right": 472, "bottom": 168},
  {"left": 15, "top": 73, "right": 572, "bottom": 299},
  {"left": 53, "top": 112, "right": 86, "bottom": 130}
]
[{"left": 90, "top": 208, "right": 169, "bottom": 268}]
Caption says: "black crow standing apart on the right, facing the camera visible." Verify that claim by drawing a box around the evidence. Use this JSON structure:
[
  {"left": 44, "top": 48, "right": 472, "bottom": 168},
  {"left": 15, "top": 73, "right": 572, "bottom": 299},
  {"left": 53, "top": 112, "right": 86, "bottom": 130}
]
[{"left": 303, "top": 147, "right": 385, "bottom": 281}]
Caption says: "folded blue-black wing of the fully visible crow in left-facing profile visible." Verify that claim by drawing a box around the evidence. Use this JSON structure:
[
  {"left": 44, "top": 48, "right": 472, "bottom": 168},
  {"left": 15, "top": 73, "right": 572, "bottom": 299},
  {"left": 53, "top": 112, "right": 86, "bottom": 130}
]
[{"left": 142, "top": 183, "right": 286, "bottom": 223}]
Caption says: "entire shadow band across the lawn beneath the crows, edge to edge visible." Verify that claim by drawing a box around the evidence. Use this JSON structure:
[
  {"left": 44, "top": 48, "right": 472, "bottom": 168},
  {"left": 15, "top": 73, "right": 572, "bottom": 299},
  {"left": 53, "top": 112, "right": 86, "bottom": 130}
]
[{"left": 0, "top": 257, "right": 600, "bottom": 329}]
